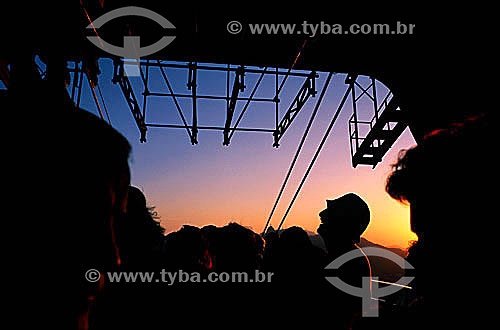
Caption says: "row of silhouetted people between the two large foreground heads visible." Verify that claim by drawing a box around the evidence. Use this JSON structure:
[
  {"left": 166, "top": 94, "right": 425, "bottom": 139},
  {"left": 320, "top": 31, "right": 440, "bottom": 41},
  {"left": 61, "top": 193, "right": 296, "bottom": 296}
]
[{"left": 92, "top": 187, "right": 380, "bottom": 329}]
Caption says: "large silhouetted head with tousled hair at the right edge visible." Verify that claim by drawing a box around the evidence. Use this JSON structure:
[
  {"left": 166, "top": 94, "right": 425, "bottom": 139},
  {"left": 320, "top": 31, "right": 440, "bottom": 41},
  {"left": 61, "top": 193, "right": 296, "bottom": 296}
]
[{"left": 385, "top": 114, "right": 495, "bottom": 242}]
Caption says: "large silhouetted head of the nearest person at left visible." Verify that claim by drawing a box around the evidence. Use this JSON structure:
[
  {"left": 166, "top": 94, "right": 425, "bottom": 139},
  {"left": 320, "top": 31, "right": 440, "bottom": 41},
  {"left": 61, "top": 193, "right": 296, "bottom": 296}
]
[{"left": 71, "top": 110, "right": 131, "bottom": 266}]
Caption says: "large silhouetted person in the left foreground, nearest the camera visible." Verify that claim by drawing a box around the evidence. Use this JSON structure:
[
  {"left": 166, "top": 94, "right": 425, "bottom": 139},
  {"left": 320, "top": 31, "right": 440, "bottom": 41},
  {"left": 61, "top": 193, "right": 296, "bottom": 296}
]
[{"left": 50, "top": 108, "right": 131, "bottom": 327}]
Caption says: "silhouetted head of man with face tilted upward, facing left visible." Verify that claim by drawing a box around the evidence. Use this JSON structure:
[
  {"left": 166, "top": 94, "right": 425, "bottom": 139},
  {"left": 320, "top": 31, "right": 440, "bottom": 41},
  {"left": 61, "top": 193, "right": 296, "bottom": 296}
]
[{"left": 318, "top": 193, "right": 370, "bottom": 248}]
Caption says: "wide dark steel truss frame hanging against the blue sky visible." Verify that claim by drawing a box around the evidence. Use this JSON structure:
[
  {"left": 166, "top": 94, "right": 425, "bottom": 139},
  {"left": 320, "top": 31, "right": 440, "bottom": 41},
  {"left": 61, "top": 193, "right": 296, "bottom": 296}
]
[{"left": 113, "top": 60, "right": 319, "bottom": 147}]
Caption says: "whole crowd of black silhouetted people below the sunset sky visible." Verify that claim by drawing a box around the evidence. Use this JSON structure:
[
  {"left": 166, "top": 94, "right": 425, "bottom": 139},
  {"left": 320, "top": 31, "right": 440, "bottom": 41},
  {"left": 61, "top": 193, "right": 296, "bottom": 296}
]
[{"left": 2, "top": 66, "right": 493, "bottom": 329}]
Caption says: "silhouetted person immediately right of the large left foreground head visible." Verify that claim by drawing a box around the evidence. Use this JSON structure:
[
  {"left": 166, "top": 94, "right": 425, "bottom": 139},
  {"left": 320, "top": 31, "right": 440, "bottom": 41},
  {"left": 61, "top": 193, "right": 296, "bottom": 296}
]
[{"left": 96, "top": 186, "right": 167, "bottom": 329}]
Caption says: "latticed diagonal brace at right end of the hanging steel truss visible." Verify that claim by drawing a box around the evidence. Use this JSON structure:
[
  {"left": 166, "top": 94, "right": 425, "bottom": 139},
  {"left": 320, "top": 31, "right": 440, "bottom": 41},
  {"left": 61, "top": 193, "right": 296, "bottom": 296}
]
[{"left": 273, "top": 71, "right": 318, "bottom": 148}]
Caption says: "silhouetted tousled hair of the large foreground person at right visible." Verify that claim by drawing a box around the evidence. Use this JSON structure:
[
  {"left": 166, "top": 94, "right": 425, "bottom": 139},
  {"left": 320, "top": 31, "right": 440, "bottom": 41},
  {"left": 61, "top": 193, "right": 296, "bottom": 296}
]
[{"left": 385, "top": 114, "right": 491, "bottom": 203}]
